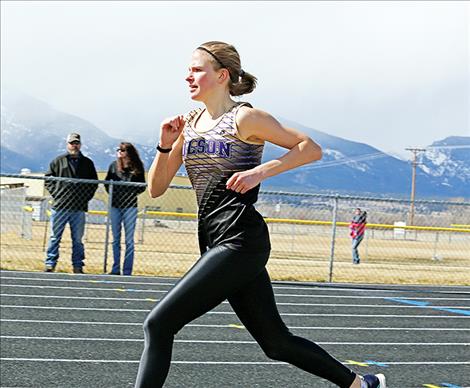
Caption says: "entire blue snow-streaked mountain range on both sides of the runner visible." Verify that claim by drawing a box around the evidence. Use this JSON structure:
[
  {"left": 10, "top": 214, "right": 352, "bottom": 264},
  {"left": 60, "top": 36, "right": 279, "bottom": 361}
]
[{"left": 0, "top": 90, "right": 470, "bottom": 198}]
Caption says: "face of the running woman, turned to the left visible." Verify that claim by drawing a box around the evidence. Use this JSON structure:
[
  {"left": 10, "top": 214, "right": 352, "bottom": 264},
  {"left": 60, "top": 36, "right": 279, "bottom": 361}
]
[{"left": 186, "top": 50, "right": 220, "bottom": 101}]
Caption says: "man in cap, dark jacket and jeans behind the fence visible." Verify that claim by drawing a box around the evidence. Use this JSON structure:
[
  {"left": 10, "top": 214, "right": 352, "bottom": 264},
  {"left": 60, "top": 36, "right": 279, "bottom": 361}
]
[{"left": 45, "top": 133, "right": 98, "bottom": 273}]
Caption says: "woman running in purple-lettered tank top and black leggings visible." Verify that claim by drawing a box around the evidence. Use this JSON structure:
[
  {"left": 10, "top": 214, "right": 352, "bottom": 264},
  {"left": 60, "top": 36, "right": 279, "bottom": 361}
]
[{"left": 136, "top": 41, "right": 385, "bottom": 388}]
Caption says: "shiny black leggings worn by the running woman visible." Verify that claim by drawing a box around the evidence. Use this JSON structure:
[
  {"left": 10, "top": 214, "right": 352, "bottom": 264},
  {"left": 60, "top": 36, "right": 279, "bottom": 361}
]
[{"left": 136, "top": 246, "right": 356, "bottom": 388}]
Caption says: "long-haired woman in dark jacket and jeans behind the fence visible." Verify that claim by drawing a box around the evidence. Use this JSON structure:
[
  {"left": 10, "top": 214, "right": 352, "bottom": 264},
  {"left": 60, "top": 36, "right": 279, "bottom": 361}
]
[{"left": 105, "top": 142, "right": 145, "bottom": 275}]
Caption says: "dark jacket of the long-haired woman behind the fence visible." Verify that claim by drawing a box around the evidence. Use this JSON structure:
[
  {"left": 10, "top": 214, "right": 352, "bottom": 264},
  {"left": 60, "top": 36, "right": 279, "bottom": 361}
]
[{"left": 104, "top": 161, "right": 146, "bottom": 209}]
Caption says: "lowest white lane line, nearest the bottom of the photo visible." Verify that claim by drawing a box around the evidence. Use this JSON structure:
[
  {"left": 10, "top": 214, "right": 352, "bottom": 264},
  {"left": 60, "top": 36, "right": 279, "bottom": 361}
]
[{"left": 0, "top": 357, "right": 470, "bottom": 366}]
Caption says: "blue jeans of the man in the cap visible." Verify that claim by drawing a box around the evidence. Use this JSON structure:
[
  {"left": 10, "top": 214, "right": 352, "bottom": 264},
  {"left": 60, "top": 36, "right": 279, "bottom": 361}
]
[{"left": 45, "top": 209, "right": 85, "bottom": 267}]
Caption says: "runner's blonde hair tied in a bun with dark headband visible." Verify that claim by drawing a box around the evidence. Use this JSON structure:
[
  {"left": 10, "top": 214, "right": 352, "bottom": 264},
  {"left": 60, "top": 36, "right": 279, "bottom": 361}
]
[{"left": 197, "top": 41, "right": 258, "bottom": 96}]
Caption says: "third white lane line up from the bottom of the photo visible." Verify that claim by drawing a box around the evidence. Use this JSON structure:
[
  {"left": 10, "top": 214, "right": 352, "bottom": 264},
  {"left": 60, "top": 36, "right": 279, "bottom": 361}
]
[{"left": 0, "top": 318, "right": 470, "bottom": 331}]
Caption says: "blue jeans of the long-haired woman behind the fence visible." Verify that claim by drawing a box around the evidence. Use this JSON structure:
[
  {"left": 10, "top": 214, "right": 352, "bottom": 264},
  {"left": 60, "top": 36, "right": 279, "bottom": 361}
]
[{"left": 111, "top": 207, "right": 137, "bottom": 275}]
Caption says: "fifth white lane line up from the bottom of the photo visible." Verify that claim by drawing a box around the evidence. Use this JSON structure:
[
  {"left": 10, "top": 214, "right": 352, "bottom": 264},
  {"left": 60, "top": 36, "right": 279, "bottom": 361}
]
[{"left": 0, "top": 293, "right": 470, "bottom": 310}]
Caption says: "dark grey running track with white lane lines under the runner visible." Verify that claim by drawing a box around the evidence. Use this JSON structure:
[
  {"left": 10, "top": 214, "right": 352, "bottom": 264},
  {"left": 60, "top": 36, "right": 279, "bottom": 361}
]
[{"left": 0, "top": 271, "right": 470, "bottom": 388}]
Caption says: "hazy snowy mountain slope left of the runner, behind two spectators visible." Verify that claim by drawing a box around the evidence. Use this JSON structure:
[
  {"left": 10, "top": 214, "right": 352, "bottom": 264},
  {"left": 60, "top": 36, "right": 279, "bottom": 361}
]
[{"left": 1, "top": 89, "right": 154, "bottom": 172}]
